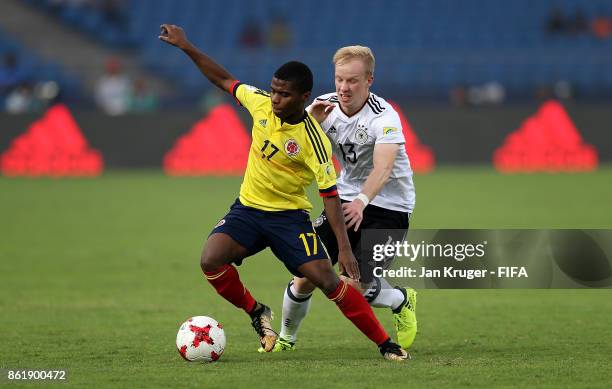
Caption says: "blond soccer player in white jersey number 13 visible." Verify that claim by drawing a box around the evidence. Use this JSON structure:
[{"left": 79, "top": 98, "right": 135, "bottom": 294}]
[{"left": 258, "top": 46, "right": 417, "bottom": 351}]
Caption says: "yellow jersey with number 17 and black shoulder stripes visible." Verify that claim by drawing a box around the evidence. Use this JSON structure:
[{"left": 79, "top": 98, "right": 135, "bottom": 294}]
[{"left": 231, "top": 82, "right": 338, "bottom": 211}]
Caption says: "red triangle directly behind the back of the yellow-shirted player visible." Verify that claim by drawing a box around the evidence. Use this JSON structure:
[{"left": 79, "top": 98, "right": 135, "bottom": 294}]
[{"left": 164, "top": 104, "right": 251, "bottom": 176}]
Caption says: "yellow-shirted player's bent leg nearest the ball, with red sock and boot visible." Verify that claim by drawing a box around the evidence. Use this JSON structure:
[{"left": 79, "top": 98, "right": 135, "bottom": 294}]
[{"left": 200, "top": 203, "right": 277, "bottom": 352}]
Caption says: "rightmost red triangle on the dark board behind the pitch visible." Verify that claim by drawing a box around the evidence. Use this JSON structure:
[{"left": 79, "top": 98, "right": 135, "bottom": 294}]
[{"left": 493, "top": 100, "right": 599, "bottom": 173}]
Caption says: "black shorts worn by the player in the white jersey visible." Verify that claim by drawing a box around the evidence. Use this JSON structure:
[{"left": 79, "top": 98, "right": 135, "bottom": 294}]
[{"left": 313, "top": 201, "right": 410, "bottom": 283}]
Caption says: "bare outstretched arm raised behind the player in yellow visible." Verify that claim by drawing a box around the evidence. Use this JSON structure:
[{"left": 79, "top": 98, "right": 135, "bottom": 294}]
[{"left": 159, "top": 24, "right": 236, "bottom": 93}]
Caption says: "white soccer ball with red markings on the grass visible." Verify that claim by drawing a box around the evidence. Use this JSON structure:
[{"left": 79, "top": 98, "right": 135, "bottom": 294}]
[{"left": 176, "top": 316, "right": 225, "bottom": 362}]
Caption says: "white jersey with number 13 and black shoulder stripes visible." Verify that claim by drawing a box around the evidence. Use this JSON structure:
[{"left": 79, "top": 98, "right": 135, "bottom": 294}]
[{"left": 307, "top": 93, "right": 415, "bottom": 213}]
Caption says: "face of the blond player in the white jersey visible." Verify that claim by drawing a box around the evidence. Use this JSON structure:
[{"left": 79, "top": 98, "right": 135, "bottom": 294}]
[{"left": 336, "top": 59, "right": 374, "bottom": 111}]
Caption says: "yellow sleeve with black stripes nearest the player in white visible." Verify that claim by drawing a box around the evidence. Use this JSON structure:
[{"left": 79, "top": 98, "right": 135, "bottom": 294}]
[{"left": 304, "top": 113, "right": 338, "bottom": 197}]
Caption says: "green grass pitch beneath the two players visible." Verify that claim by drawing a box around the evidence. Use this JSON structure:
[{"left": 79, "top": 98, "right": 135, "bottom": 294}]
[{"left": 0, "top": 167, "right": 612, "bottom": 388}]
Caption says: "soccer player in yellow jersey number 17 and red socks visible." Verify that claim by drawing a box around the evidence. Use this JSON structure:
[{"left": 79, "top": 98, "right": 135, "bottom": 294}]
[{"left": 159, "top": 24, "right": 408, "bottom": 361}]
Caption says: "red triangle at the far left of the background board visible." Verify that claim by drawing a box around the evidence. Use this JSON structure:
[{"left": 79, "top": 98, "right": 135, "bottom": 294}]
[{"left": 0, "top": 104, "right": 104, "bottom": 177}]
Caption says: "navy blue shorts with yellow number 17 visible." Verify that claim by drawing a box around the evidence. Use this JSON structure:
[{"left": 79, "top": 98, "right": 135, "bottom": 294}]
[{"left": 210, "top": 200, "right": 329, "bottom": 277}]
